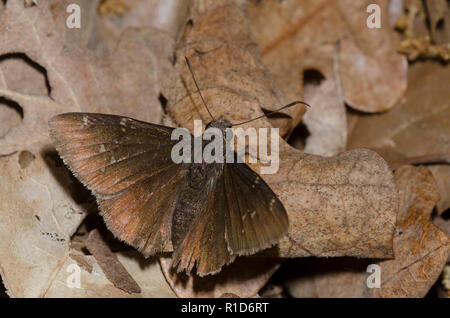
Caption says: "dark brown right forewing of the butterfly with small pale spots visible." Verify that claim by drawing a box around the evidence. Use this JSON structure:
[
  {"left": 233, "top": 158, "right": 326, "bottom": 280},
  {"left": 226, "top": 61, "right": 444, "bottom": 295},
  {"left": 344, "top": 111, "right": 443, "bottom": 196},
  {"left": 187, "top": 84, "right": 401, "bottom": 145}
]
[{"left": 223, "top": 163, "right": 289, "bottom": 255}]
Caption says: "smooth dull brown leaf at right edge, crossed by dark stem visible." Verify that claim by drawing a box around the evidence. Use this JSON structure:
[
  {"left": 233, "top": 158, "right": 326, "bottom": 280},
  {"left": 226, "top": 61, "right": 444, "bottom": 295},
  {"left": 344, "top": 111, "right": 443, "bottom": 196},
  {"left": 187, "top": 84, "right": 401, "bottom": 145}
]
[{"left": 348, "top": 62, "right": 450, "bottom": 213}]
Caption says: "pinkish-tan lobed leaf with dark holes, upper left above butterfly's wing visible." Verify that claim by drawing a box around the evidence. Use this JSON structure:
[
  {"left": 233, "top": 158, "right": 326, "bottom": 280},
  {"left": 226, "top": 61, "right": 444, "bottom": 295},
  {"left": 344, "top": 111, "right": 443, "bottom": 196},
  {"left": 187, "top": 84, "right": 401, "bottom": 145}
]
[{"left": 0, "top": 1, "right": 171, "bottom": 153}]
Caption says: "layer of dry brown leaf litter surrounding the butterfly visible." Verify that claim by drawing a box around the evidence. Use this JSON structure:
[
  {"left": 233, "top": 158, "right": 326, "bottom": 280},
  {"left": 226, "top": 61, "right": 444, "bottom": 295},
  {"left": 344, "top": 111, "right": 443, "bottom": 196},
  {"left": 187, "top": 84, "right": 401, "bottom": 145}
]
[{"left": 0, "top": 0, "right": 449, "bottom": 297}]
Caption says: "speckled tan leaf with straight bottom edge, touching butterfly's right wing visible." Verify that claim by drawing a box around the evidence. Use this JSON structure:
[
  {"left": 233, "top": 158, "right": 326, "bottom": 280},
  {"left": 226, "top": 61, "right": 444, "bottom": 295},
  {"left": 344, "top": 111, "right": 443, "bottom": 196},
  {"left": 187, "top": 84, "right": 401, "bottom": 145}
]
[{"left": 262, "top": 146, "right": 398, "bottom": 258}]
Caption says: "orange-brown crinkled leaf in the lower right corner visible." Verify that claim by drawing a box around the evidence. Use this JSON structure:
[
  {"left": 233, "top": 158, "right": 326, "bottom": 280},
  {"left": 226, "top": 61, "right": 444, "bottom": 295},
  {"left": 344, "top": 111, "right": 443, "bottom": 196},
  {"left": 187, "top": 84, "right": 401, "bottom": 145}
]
[{"left": 373, "top": 166, "right": 450, "bottom": 297}]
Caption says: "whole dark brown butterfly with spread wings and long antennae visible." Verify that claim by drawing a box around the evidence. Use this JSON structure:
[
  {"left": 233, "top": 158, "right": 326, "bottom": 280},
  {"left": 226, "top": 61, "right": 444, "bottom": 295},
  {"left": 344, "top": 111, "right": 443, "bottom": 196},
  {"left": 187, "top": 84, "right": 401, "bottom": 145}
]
[{"left": 49, "top": 59, "right": 310, "bottom": 276}]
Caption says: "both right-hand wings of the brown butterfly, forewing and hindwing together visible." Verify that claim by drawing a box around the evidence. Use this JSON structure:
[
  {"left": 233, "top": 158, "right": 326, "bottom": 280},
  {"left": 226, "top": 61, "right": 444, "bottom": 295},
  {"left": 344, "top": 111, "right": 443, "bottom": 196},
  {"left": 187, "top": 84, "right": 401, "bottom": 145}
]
[{"left": 173, "top": 163, "right": 288, "bottom": 275}]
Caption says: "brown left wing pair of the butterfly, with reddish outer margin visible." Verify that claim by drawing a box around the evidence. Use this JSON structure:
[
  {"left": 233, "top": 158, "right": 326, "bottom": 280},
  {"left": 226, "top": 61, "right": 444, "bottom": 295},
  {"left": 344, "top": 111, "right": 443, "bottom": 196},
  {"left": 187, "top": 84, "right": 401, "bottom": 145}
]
[{"left": 50, "top": 113, "right": 186, "bottom": 256}]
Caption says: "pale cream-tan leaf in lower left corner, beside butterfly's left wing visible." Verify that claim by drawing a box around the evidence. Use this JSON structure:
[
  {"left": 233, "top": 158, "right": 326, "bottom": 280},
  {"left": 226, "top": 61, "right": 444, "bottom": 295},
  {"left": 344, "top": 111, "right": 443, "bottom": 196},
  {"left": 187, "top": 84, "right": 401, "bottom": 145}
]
[{"left": 0, "top": 152, "right": 86, "bottom": 297}]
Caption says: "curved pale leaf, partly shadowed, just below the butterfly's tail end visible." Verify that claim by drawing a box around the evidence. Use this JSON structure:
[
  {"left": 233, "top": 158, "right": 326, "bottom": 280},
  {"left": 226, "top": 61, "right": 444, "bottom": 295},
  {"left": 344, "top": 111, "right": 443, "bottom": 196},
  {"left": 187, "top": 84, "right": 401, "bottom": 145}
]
[{"left": 160, "top": 257, "right": 280, "bottom": 297}]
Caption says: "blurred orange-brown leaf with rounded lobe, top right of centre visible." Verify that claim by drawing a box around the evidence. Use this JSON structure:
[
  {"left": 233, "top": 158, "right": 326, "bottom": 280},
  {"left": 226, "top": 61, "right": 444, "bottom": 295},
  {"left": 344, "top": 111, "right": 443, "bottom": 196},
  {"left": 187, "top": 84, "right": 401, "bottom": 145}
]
[{"left": 250, "top": 0, "right": 407, "bottom": 112}]
